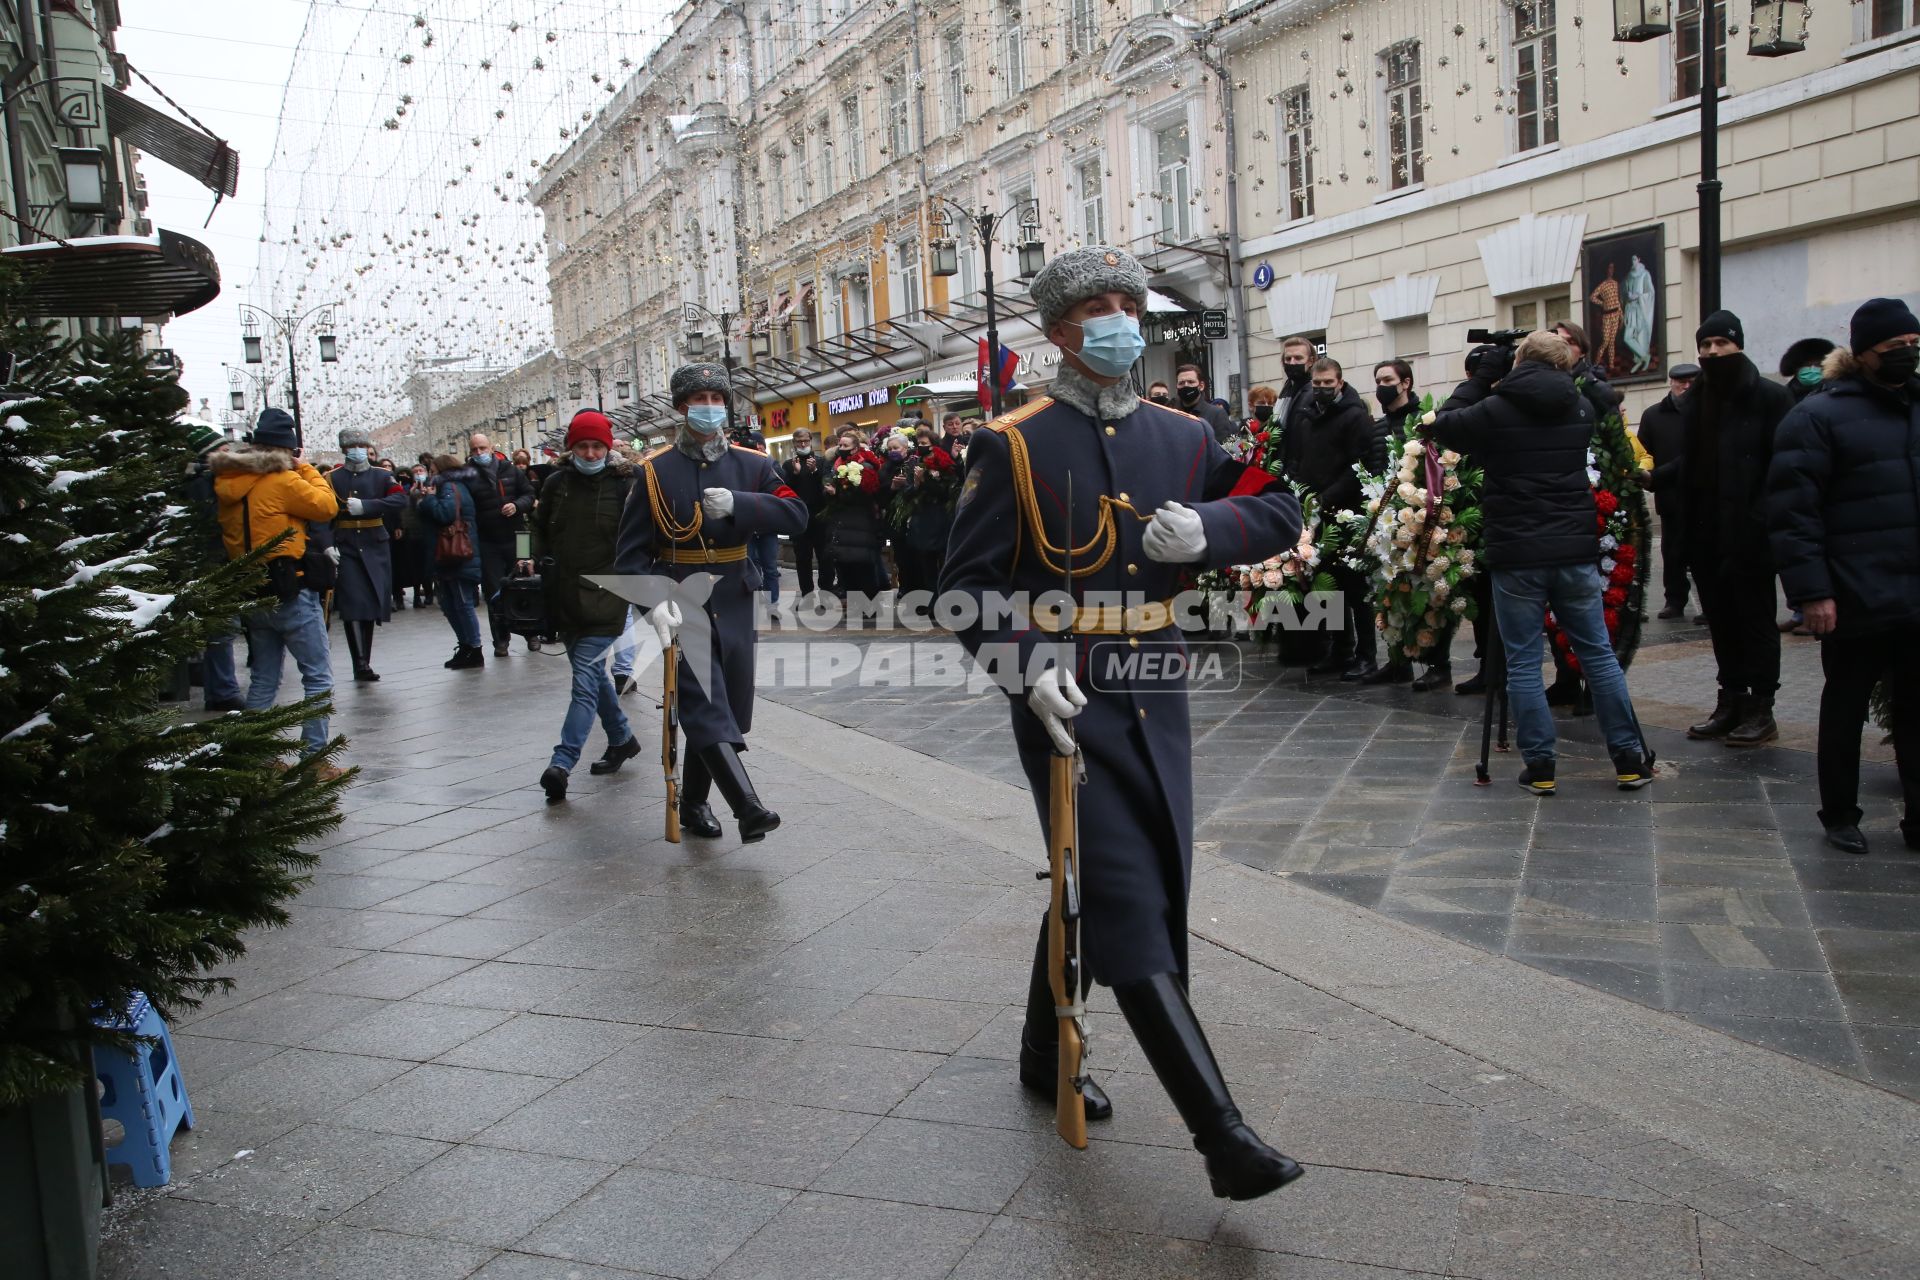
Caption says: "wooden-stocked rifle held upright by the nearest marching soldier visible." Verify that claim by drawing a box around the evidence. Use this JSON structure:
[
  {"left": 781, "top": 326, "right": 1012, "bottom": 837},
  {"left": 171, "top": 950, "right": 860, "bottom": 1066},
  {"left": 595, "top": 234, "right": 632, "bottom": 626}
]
[{"left": 1046, "top": 474, "right": 1087, "bottom": 1150}]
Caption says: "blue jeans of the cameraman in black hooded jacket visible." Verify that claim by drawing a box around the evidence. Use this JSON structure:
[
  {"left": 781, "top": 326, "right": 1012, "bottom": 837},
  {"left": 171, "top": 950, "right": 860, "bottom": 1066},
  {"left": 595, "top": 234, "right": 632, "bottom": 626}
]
[{"left": 1494, "top": 564, "right": 1642, "bottom": 764}]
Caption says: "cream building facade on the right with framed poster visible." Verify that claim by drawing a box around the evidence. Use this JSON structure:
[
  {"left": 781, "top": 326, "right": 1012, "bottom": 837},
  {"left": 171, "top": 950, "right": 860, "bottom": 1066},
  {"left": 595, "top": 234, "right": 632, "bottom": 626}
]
[{"left": 1221, "top": 0, "right": 1920, "bottom": 415}]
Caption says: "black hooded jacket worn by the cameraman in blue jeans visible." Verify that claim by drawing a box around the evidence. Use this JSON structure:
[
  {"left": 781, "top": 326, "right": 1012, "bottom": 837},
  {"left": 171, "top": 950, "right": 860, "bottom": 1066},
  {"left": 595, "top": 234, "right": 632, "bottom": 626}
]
[{"left": 1432, "top": 361, "right": 1599, "bottom": 568}]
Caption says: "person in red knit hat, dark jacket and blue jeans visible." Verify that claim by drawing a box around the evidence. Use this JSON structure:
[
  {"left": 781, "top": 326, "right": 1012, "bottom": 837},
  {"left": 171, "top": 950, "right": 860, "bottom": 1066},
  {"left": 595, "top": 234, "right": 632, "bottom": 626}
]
[{"left": 520, "top": 409, "right": 639, "bottom": 804}]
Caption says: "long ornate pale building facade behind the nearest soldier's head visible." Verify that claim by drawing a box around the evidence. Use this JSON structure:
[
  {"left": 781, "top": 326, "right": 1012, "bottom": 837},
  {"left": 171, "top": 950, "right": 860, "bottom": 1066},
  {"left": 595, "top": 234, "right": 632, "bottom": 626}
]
[{"left": 532, "top": 0, "right": 1238, "bottom": 450}]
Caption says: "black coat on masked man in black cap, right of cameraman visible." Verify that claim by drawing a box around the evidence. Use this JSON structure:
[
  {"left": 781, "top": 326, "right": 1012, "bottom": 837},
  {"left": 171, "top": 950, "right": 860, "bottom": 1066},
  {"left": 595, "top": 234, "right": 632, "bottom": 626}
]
[{"left": 1653, "top": 355, "right": 1793, "bottom": 574}]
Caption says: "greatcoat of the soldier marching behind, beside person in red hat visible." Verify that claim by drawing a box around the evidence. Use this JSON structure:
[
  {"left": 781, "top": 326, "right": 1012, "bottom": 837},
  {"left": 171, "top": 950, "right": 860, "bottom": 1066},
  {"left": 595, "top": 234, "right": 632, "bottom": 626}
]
[{"left": 614, "top": 445, "right": 806, "bottom": 750}]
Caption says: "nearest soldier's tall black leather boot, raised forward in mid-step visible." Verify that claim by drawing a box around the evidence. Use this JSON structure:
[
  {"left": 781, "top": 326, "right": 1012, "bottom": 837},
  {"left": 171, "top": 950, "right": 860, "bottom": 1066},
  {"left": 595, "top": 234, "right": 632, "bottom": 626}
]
[{"left": 1114, "top": 973, "right": 1306, "bottom": 1199}]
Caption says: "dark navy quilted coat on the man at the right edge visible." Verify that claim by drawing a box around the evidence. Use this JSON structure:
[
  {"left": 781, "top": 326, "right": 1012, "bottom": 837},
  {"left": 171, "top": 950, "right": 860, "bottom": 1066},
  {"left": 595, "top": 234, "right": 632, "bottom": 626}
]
[{"left": 1766, "top": 347, "right": 1920, "bottom": 635}]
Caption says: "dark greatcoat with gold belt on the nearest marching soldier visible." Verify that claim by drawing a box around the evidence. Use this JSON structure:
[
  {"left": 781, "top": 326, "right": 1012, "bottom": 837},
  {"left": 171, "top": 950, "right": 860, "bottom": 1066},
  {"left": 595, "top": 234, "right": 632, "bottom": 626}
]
[{"left": 941, "top": 399, "right": 1300, "bottom": 984}]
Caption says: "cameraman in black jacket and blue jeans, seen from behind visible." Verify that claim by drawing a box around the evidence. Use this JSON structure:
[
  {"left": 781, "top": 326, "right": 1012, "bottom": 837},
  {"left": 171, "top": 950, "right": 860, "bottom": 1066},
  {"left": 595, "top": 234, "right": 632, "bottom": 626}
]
[{"left": 1430, "top": 332, "right": 1653, "bottom": 794}]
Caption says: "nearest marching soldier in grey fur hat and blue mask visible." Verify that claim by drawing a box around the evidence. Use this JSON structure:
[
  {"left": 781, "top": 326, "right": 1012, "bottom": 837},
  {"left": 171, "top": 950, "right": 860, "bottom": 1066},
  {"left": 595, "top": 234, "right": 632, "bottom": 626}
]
[{"left": 941, "top": 246, "right": 1300, "bottom": 1199}]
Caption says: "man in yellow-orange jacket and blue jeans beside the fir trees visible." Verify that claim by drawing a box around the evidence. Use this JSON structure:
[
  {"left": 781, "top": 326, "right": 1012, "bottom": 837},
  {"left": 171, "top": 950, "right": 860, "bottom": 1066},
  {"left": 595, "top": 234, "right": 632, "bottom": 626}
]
[{"left": 213, "top": 409, "right": 340, "bottom": 756}]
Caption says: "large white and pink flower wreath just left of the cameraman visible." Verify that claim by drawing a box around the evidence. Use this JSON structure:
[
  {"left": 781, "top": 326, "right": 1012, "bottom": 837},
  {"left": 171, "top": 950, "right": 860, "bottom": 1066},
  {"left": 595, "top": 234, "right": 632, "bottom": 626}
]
[{"left": 1342, "top": 395, "right": 1480, "bottom": 660}]
